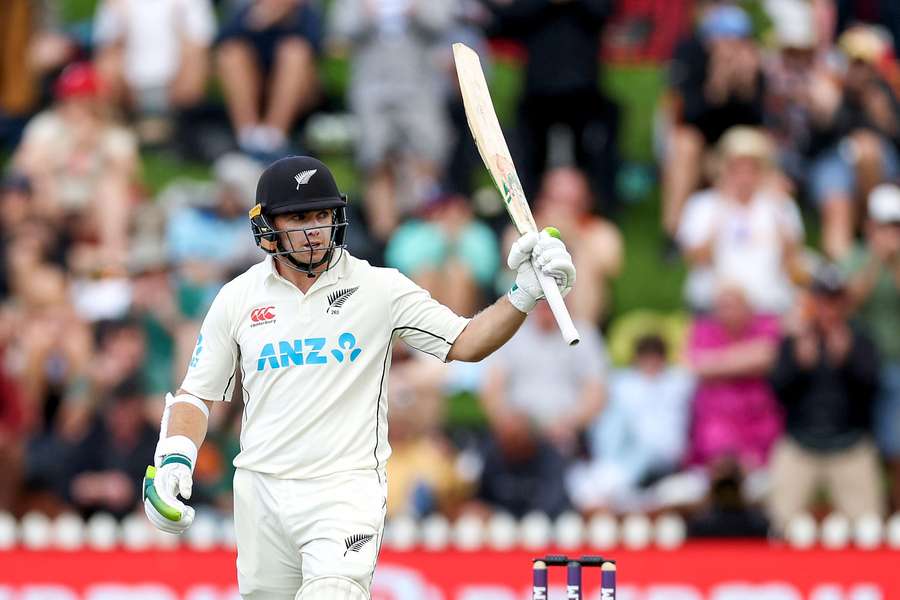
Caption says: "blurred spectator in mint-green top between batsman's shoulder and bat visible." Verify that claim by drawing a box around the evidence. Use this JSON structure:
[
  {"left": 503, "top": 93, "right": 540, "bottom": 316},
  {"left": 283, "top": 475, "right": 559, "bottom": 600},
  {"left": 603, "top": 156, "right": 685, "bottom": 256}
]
[{"left": 385, "top": 191, "right": 500, "bottom": 315}]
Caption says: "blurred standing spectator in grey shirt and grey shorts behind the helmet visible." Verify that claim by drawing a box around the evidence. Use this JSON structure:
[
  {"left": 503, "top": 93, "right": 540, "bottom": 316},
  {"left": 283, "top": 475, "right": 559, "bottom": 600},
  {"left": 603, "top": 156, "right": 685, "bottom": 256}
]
[{"left": 331, "top": 0, "right": 456, "bottom": 242}]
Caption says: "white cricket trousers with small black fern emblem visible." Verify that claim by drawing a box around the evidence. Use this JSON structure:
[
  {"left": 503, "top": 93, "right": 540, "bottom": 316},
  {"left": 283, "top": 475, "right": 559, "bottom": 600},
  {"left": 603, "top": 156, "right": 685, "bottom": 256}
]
[{"left": 234, "top": 469, "right": 387, "bottom": 600}]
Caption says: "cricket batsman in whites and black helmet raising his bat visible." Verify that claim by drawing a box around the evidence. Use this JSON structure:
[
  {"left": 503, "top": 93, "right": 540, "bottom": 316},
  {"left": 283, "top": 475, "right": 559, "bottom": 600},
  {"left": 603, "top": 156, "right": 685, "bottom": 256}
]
[{"left": 144, "top": 156, "right": 575, "bottom": 600}]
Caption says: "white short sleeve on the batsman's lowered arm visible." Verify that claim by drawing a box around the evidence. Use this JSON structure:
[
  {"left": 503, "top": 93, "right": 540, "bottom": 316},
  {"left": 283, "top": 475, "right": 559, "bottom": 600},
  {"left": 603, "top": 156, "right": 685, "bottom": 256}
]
[{"left": 181, "top": 287, "right": 238, "bottom": 400}]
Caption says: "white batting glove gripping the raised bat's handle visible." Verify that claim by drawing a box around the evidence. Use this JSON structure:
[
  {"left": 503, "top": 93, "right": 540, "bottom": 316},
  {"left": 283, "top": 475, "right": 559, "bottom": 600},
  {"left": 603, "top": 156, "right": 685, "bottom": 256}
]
[{"left": 506, "top": 227, "right": 575, "bottom": 314}]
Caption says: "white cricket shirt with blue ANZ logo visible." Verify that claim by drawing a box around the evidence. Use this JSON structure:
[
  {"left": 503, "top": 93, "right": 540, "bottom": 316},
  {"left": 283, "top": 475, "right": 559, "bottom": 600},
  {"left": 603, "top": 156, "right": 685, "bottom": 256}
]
[{"left": 181, "top": 252, "right": 469, "bottom": 479}]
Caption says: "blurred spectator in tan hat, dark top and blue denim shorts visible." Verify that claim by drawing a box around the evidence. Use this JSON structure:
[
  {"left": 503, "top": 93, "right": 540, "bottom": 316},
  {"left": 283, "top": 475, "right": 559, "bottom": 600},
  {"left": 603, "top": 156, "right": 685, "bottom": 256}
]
[{"left": 809, "top": 26, "right": 900, "bottom": 259}]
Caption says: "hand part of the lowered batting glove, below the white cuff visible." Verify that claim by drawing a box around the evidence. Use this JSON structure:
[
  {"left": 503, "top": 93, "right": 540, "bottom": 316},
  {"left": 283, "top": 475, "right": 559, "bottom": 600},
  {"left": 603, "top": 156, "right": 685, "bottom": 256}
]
[{"left": 143, "top": 454, "right": 194, "bottom": 534}]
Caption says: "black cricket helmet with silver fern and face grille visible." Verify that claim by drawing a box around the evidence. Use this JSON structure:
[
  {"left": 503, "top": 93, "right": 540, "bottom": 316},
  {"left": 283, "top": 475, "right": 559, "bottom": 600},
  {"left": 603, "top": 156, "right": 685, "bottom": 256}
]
[{"left": 250, "top": 156, "right": 347, "bottom": 276}]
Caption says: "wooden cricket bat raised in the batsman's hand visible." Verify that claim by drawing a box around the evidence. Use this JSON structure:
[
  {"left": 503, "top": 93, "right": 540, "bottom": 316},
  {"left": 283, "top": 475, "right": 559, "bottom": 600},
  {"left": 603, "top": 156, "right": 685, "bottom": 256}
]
[{"left": 453, "top": 43, "right": 580, "bottom": 346}]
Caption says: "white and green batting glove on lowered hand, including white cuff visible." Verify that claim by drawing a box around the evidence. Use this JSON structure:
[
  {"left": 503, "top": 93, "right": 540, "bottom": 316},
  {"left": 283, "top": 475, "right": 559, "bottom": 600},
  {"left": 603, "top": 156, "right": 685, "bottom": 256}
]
[{"left": 143, "top": 436, "right": 197, "bottom": 534}]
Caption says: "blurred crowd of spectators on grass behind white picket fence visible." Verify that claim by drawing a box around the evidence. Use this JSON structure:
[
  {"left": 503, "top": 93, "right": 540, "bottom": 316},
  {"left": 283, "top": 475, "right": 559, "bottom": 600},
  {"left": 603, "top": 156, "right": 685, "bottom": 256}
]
[{"left": 0, "top": 0, "right": 900, "bottom": 535}]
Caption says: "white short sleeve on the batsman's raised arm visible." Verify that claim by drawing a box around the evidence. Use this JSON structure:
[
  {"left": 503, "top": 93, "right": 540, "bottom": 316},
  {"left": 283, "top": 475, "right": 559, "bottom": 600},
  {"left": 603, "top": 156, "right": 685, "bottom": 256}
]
[{"left": 388, "top": 269, "right": 469, "bottom": 361}]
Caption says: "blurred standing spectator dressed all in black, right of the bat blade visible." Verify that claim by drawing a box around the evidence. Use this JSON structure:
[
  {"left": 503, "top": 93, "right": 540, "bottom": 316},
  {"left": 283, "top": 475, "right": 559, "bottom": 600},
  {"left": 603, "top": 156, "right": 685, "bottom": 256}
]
[{"left": 488, "top": 0, "right": 619, "bottom": 210}]
